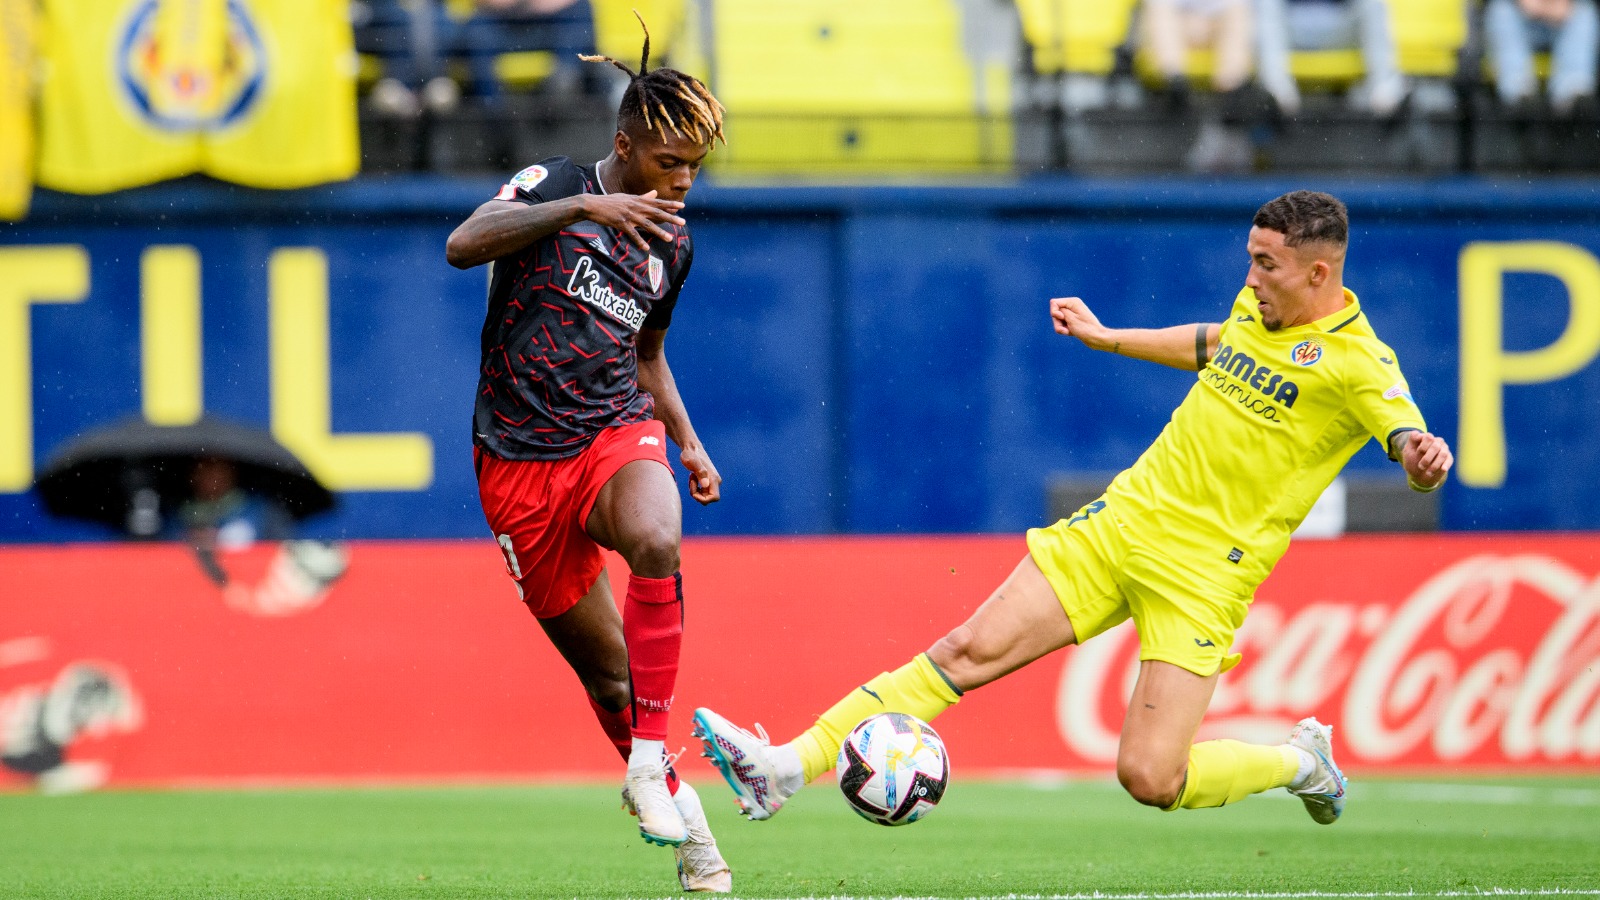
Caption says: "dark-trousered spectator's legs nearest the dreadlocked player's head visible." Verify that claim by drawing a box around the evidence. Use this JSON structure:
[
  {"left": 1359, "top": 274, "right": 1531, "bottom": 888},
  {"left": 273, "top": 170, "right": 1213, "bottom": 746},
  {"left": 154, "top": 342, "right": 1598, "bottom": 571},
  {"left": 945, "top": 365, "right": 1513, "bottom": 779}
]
[{"left": 461, "top": 0, "right": 603, "bottom": 102}]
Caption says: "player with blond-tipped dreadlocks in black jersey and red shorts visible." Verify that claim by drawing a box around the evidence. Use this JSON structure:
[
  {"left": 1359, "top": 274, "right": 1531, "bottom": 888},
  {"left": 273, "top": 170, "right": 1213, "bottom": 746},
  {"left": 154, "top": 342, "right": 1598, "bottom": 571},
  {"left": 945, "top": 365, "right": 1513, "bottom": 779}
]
[{"left": 446, "top": 19, "right": 733, "bottom": 892}]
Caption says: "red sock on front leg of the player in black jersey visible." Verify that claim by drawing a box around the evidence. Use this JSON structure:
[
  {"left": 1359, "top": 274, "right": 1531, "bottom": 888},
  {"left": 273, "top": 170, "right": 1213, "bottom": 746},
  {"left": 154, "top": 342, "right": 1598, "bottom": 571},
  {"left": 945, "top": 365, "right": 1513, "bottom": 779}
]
[{"left": 622, "top": 573, "right": 683, "bottom": 740}]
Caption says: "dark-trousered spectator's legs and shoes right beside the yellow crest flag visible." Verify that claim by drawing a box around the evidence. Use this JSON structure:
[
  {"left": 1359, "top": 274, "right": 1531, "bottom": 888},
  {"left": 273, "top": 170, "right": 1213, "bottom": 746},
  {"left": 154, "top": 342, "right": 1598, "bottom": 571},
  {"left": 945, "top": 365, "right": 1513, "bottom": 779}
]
[{"left": 350, "top": 0, "right": 461, "bottom": 119}]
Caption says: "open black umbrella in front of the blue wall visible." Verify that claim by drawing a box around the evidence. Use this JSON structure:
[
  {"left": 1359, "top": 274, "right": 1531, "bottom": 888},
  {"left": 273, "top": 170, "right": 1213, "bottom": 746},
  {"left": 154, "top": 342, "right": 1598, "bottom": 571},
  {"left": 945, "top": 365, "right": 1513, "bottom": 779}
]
[{"left": 34, "top": 416, "right": 334, "bottom": 535}]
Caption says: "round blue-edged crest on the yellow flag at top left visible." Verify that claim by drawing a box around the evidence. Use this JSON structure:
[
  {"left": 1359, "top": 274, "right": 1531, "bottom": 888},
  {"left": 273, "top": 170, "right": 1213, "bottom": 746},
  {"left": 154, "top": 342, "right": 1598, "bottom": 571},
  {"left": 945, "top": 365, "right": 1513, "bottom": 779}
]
[{"left": 115, "top": 0, "right": 267, "bottom": 131}]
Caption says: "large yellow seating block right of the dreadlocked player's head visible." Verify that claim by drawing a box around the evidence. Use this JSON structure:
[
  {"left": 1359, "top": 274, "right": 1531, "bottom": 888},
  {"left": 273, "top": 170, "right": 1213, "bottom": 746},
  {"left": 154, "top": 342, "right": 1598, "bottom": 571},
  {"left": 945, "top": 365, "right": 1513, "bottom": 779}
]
[{"left": 712, "top": 0, "right": 1013, "bottom": 175}]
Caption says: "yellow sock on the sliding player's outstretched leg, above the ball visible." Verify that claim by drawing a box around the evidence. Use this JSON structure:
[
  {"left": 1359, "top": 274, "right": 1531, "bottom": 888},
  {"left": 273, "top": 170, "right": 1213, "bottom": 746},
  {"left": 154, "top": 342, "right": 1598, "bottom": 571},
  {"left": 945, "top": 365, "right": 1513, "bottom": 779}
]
[{"left": 794, "top": 653, "right": 962, "bottom": 783}]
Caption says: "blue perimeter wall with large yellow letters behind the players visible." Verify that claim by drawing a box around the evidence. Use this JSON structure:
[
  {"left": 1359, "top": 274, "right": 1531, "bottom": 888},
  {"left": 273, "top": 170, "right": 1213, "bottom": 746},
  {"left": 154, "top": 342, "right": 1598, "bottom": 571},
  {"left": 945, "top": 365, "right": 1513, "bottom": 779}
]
[{"left": 0, "top": 178, "right": 1600, "bottom": 541}]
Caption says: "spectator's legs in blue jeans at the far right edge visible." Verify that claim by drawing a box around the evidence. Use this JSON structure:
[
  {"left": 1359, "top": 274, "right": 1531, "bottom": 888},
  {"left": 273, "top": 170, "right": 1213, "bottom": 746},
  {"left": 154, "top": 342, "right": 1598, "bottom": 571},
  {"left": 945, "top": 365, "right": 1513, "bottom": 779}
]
[{"left": 1483, "top": 0, "right": 1600, "bottom": 119}]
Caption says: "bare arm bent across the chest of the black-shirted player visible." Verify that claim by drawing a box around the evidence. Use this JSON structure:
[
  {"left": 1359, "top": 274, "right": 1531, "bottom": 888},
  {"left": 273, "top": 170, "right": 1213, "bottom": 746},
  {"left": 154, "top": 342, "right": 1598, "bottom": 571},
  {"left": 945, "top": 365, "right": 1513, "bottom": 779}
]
[{"left": 445, "top": 191, "right": 683, "bottom": 269}]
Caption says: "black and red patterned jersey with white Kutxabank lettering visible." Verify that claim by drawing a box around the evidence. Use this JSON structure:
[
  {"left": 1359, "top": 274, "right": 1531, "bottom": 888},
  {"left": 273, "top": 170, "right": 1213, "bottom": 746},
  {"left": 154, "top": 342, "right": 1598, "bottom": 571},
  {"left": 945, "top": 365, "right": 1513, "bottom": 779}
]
[{"left": 472, "top": 157, "right": 694, "bottom": 460}]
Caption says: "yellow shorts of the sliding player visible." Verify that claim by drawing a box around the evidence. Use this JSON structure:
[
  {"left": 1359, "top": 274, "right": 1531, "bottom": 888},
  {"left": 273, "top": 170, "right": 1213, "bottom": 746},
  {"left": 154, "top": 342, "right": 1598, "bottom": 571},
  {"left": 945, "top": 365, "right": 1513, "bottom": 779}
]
[{"left": 1027, "top": 496, "right": 1254, "bottom": 676}]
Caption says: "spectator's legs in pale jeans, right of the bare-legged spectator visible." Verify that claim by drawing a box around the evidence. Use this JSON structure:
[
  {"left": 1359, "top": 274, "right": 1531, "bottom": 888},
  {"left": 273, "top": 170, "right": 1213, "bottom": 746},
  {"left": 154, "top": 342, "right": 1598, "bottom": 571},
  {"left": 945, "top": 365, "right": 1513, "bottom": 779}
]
[{"left": 1256, "top": 0, "right": 1406, "bottom": 119}]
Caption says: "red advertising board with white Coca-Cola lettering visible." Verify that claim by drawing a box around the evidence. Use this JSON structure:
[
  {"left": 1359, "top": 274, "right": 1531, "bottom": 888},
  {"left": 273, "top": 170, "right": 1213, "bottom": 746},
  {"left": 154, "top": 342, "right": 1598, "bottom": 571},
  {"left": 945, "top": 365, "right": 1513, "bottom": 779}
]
[{"left": 0, "top": 535, "right": 1600, "bottom": 788}]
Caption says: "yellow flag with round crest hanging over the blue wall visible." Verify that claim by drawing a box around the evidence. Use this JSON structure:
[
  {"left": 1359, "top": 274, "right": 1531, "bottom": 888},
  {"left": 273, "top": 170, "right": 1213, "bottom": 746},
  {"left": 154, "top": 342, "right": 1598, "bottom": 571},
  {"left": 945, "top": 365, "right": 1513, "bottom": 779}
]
[{"left": 38, "top": 0, "right": 360, "bottom": 194}]
